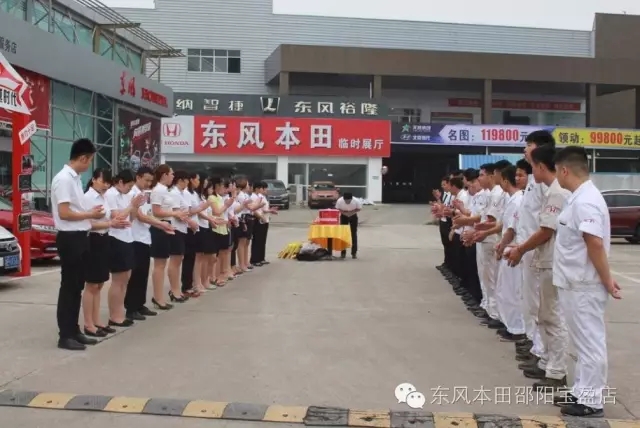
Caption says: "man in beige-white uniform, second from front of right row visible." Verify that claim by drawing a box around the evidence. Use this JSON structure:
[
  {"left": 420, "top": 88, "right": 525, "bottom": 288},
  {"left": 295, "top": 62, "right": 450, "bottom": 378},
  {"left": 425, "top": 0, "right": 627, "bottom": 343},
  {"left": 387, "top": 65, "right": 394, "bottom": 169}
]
[{"left": 509, "top": 146, "right": 571, "bottom": 390}]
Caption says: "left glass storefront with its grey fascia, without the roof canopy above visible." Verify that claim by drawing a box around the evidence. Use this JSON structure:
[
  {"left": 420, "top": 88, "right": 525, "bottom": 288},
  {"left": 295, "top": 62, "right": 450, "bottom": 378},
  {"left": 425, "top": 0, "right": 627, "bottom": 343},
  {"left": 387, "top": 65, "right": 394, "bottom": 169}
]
[{"left": 0, "top": 13, "right": 173, "bottom": 209}]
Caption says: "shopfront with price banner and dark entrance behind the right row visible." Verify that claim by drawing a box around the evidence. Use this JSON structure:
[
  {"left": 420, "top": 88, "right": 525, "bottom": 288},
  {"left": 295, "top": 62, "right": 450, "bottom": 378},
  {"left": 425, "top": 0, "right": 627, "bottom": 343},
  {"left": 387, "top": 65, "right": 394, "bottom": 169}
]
[{"left": 383, "top": 123, "right": 640, "bottom": 203}]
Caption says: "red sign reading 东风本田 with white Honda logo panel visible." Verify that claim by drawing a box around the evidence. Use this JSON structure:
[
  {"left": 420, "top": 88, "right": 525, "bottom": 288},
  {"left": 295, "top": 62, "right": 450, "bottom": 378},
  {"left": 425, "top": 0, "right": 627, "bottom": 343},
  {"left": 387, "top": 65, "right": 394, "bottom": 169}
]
[{"left": 162, "top": 116, "right": 391, "bottom": 157}]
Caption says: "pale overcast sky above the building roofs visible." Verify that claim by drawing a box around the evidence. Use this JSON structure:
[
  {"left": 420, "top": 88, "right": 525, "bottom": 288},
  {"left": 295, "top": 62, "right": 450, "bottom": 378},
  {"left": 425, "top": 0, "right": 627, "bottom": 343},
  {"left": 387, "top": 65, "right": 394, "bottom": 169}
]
[{"left": 102, "top": 0, "right": 640, "bottom": 30}]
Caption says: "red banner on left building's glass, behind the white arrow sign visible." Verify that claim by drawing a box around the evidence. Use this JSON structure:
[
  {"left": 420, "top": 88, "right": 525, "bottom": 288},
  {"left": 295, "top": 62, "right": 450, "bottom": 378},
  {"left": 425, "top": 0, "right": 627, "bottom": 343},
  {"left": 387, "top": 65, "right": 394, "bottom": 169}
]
[{"left": 0, "top": 67, "right": 51, "bottom": 129}]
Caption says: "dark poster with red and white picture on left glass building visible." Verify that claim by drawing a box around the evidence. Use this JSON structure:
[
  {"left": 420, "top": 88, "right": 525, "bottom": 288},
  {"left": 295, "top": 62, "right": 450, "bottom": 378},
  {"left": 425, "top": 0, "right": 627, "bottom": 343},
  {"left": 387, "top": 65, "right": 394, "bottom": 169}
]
[{"left": 116, "top": 108, "right": 160, "bottom": 172}]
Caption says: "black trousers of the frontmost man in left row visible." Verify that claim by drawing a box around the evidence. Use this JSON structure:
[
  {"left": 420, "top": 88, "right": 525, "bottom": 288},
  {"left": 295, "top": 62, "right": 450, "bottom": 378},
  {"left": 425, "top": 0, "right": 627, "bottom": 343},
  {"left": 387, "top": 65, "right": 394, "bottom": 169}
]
[{"left": 56, "top": 231, "right": 89, "bottom": 339}]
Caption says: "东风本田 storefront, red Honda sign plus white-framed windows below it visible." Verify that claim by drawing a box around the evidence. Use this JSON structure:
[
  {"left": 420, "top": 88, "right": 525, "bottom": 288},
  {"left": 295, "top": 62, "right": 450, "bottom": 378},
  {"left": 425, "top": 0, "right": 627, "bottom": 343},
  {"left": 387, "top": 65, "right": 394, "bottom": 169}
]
[{"left": 161, "top": 115, "right": 391, "bottom": 201}]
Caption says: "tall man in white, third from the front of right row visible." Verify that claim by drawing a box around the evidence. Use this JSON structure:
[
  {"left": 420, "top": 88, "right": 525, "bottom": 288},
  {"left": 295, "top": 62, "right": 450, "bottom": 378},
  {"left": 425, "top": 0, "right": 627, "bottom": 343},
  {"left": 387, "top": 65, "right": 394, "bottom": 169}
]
[{"left": 516, "top": 131, "right": 555, "bottom": 370}]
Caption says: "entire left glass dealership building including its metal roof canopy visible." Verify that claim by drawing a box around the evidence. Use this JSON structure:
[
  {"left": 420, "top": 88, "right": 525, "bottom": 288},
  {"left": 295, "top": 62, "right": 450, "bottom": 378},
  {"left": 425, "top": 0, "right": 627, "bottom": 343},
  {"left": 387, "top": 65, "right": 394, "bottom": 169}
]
[{"left": 0, "top": 0, "right": 175, "bottom": 208}]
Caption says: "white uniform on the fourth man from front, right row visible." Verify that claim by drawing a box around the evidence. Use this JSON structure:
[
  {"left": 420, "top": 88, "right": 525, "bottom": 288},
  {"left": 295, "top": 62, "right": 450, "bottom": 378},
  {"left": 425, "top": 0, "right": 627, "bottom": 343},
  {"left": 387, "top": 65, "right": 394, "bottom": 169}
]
[{"left": 495, "top": 190, "right": 524, "bottom": 334}]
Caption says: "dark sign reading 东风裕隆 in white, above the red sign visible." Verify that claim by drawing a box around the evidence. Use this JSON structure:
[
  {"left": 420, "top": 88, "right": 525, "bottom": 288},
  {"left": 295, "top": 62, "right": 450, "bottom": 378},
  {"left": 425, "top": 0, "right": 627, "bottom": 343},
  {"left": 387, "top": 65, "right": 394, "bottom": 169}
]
[{"left": 175, "top": 93, "right": 389, "bottom": 119}]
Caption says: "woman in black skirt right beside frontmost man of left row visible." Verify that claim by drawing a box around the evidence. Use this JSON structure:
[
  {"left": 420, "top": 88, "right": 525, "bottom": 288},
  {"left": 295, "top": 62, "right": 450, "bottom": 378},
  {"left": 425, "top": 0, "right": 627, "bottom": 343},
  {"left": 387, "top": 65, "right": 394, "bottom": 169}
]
[{"left": 82, "top": 168, "right": 115, "bottom": 337}]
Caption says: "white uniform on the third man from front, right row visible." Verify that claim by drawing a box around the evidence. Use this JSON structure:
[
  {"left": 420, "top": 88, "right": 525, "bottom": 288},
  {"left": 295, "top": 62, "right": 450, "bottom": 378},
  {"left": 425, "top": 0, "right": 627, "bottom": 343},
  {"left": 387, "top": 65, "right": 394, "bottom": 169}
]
[{"left": 516, "top": 174, "right": 547, "bottom": 357}]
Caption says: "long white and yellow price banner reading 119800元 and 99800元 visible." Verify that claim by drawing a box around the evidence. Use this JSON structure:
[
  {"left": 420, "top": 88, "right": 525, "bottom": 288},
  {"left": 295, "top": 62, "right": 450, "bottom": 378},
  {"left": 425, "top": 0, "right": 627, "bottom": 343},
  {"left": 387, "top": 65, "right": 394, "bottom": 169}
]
[{"left": 391, "top": 123, "right": 640, "bottom": 149}]
